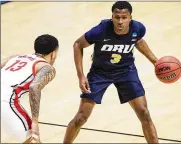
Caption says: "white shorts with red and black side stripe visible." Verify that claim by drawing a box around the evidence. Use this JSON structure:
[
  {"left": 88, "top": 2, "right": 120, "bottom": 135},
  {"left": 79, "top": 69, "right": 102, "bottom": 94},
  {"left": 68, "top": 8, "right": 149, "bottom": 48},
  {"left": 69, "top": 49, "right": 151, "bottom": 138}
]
[{"left": 1, "top": 101, "right": 32, "bottom": 143}]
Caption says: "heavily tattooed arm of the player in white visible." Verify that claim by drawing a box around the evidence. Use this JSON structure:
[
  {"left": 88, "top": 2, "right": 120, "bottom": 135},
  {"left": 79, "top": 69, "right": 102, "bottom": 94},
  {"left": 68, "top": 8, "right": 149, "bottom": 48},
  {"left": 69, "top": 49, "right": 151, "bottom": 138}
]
[{"left": 29, "top": 65, "right": 55, "bottom": 119}]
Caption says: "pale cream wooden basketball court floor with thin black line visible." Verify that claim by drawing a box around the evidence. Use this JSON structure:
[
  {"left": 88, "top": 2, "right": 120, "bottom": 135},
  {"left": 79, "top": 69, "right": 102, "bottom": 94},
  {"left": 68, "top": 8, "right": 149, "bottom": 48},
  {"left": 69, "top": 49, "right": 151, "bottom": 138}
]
[{"left": 1, "top": 2, "right": 181, "bottom": 143}]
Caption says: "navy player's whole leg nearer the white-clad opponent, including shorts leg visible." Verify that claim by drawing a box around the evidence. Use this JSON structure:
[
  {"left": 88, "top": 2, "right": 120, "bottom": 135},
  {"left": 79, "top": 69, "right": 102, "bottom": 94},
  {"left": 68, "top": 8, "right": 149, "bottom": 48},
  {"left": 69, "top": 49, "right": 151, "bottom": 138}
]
[{"left": 64, "top": 72, "right": 111, "bottom": 143}]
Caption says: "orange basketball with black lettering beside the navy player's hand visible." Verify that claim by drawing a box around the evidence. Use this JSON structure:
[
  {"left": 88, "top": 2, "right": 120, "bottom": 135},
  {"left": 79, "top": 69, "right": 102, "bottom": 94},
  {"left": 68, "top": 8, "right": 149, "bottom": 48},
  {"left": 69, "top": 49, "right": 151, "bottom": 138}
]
[{"left": 155, "top": 56, "right": 181, "bottom": 83}]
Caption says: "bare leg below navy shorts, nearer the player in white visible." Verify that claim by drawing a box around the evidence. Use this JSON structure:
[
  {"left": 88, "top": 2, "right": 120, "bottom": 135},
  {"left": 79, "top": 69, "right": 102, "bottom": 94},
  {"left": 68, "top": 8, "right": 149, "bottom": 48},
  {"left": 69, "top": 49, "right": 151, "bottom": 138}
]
[{"left": 64, "top": 98, "right": 96, "bottom": 143}]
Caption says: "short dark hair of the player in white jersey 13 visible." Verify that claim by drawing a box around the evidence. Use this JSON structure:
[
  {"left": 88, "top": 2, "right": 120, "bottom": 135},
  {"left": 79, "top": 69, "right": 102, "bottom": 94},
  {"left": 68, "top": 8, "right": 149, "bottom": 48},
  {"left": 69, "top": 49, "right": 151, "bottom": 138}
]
[{"left": 34, "top": 34, "right": 59, "bottom": 55}]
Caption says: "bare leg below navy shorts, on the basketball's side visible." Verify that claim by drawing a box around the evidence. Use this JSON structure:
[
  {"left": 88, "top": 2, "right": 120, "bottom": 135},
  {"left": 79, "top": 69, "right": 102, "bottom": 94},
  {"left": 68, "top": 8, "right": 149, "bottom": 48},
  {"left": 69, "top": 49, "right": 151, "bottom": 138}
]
[{"left": 129, "top": 96, "right": 158, "bottom": 143}]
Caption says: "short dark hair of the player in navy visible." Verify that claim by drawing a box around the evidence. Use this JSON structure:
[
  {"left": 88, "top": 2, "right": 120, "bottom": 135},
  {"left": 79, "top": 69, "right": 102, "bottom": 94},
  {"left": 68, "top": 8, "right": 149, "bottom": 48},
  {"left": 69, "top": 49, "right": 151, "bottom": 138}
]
[{"left": 112, "top": 1, "right": 132, "bottom": 14}]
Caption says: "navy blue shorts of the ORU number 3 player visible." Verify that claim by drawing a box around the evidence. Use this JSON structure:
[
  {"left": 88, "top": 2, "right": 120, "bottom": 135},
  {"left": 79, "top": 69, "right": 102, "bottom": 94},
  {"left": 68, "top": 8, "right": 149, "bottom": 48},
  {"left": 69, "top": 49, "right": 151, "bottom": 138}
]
[{"left": 81, "top": 65, "right": 145, "bottom": 104}]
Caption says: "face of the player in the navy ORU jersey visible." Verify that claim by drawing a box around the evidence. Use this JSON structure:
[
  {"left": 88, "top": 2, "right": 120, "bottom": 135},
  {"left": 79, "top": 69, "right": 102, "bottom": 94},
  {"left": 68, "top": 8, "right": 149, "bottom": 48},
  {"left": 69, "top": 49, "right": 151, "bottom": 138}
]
[{"left": 112, "top": 9, "right": 131, "bottom": 33}]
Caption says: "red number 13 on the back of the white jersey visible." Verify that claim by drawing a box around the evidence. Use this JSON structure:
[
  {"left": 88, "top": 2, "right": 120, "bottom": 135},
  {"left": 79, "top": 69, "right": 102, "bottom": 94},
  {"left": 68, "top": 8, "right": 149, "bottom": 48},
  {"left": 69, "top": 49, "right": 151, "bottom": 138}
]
[{"left": 5, "top": 60, "right": 27, "bottom": 72}]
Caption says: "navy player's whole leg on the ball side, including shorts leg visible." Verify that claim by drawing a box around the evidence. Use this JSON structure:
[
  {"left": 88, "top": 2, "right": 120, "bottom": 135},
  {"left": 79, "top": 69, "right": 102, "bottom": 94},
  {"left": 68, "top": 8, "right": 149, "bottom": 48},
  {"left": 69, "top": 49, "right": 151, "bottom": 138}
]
[{"left": 114, "top": 66, "right": 158, "bottom": 143}]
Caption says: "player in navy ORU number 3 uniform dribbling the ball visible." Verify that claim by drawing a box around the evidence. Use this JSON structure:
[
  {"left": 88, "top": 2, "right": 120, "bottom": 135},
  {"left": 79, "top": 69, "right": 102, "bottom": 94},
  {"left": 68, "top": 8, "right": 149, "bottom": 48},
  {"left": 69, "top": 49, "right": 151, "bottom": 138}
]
[{"left": 64, "top": 1, "right": 158, "bottom": 143}]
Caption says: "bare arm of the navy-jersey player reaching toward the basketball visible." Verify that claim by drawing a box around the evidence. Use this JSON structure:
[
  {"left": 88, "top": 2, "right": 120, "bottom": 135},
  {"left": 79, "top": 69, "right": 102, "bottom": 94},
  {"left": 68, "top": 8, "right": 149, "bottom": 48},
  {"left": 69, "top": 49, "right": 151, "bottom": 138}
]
[{"left": 135, "top": 39, "right": 158, "bottom": 65}]
